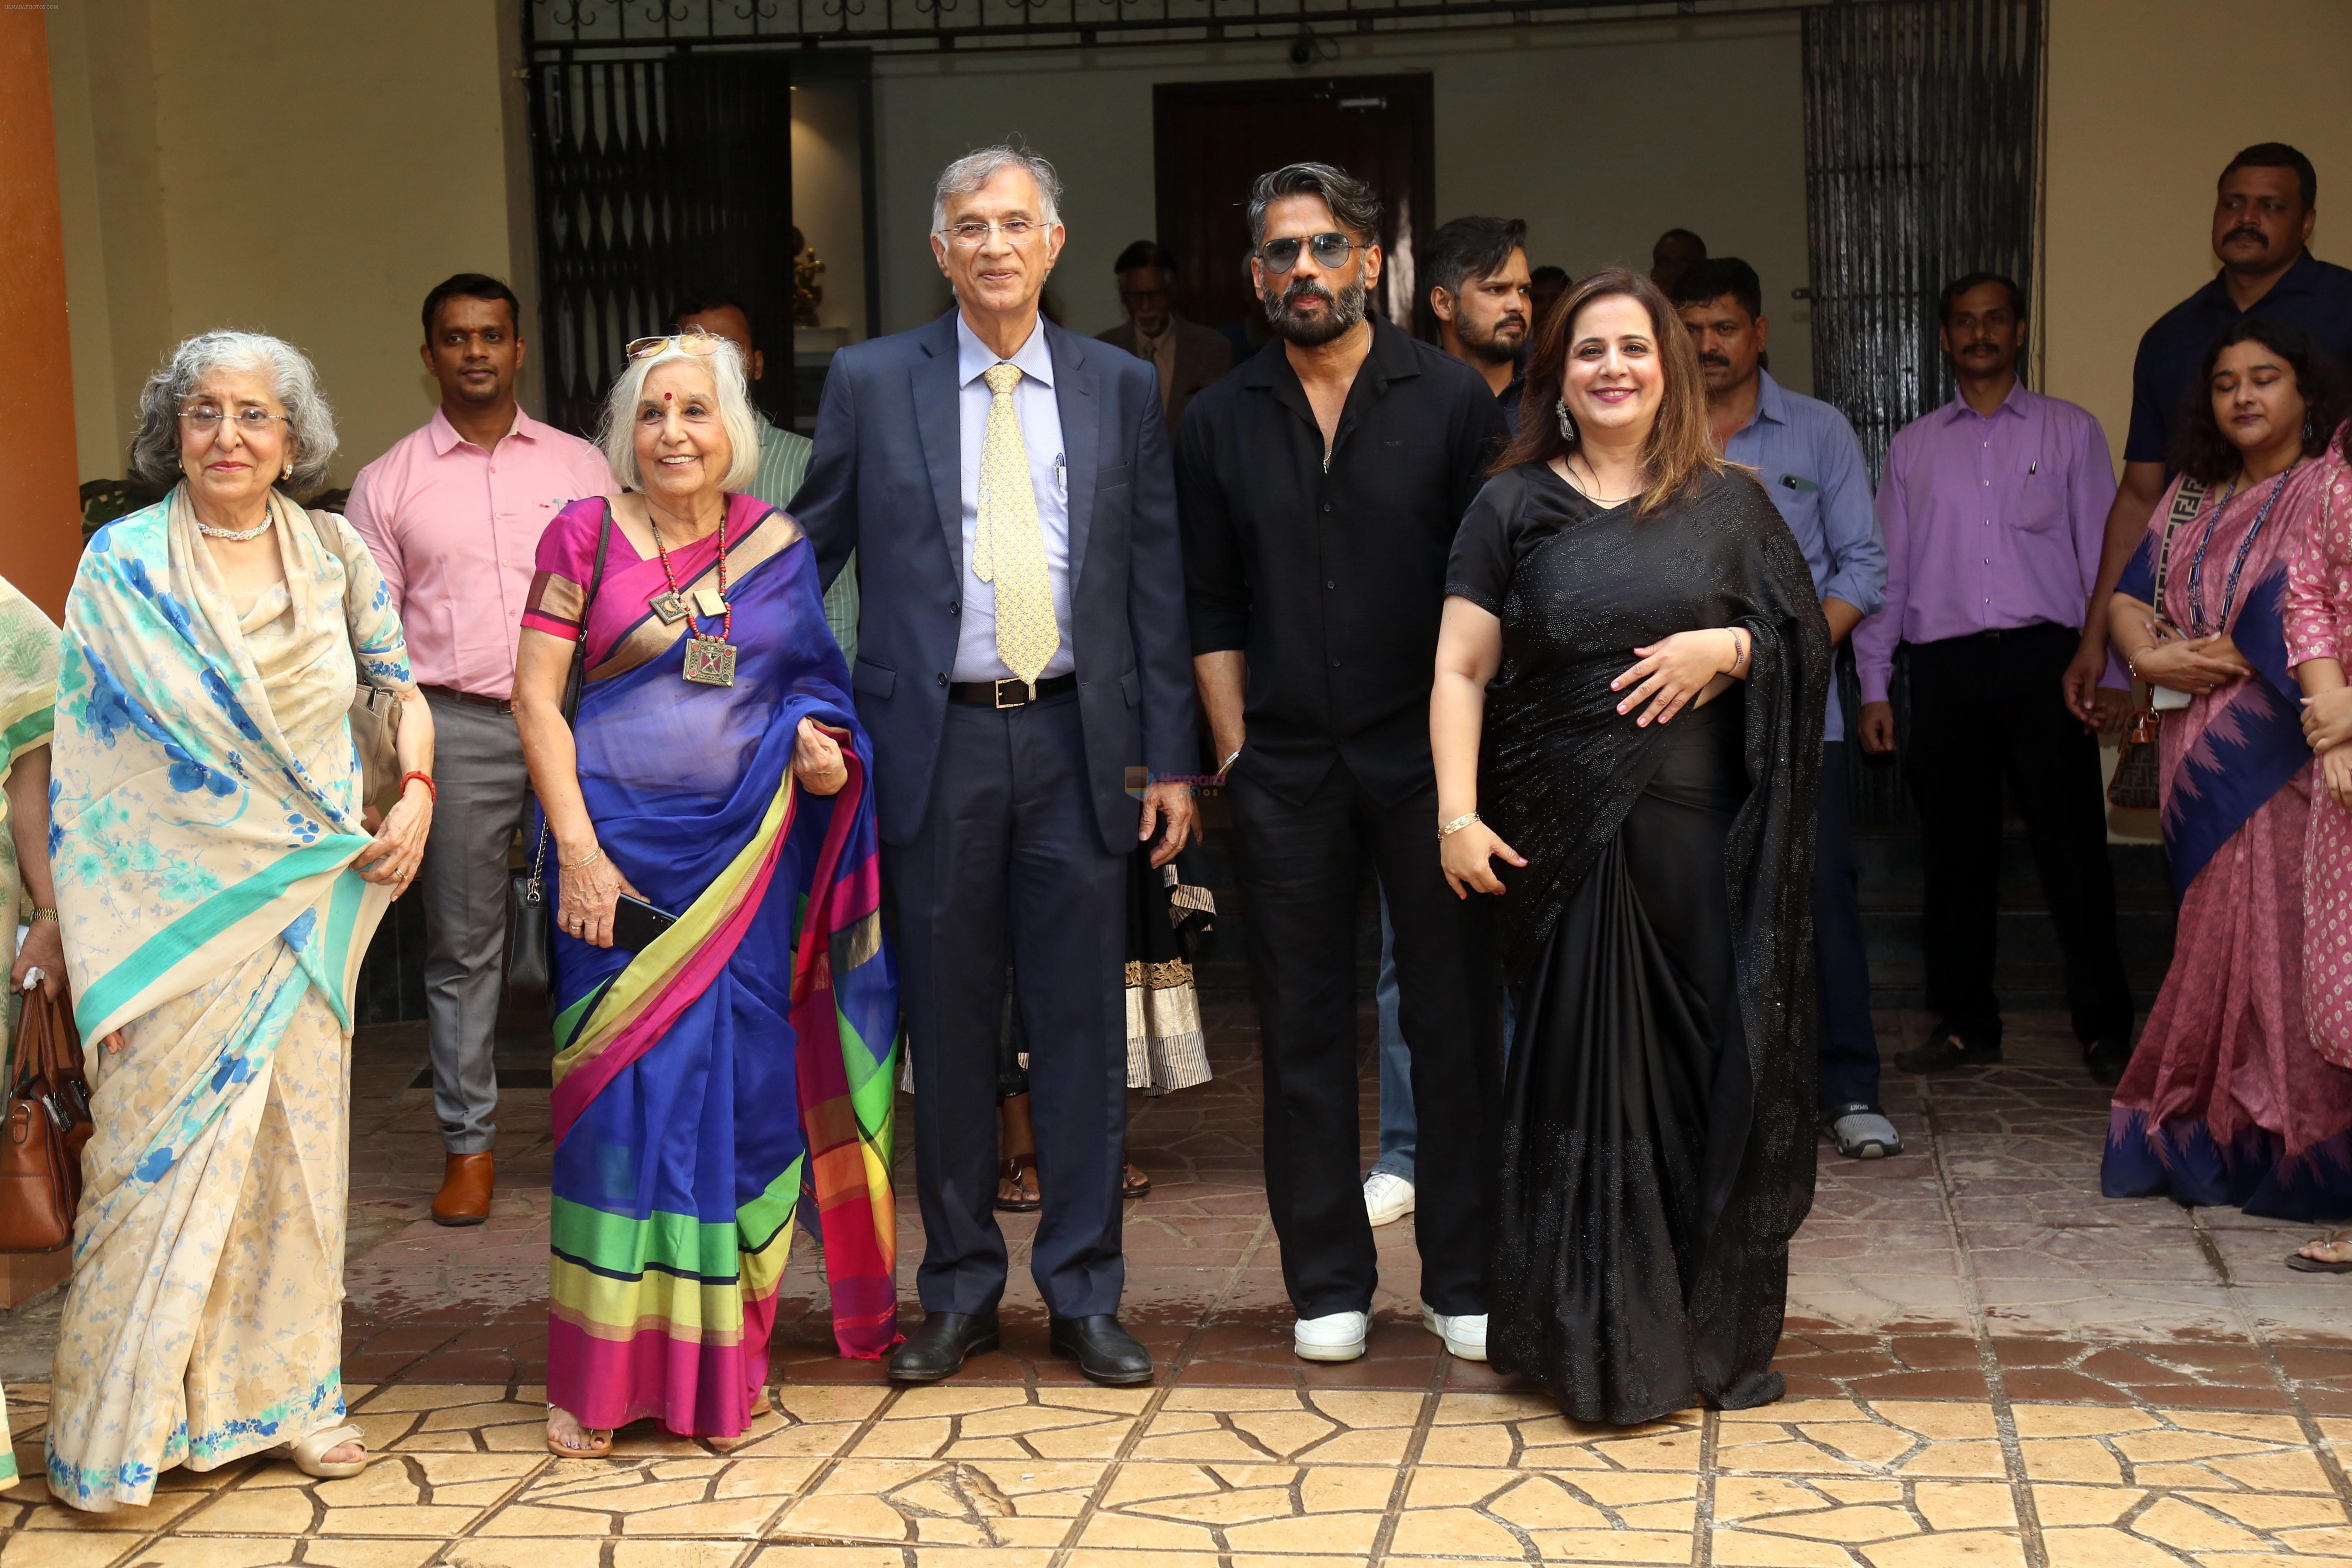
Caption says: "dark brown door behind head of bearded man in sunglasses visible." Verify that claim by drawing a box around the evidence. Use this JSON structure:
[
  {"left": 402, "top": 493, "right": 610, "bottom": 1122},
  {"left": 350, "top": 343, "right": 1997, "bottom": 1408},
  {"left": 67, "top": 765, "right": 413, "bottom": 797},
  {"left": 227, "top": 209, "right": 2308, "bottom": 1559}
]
[{"left": 1152, "top": 75, "right": 1437, "bottom": 336}]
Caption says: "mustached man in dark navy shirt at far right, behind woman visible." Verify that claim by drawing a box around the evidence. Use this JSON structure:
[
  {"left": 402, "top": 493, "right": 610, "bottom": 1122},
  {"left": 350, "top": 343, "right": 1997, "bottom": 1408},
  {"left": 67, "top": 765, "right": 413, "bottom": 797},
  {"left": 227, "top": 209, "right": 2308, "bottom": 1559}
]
[{"left": 2065, "top": 141, "right": 2352, "bottom": 729}]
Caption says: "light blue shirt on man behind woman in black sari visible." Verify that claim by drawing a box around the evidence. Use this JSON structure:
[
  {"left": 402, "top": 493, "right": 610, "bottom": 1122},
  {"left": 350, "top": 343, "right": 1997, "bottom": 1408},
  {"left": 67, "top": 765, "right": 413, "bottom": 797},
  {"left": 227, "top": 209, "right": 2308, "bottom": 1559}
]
[{"left": 1724, "top": 369, "right": 1886, "bottom": 741}]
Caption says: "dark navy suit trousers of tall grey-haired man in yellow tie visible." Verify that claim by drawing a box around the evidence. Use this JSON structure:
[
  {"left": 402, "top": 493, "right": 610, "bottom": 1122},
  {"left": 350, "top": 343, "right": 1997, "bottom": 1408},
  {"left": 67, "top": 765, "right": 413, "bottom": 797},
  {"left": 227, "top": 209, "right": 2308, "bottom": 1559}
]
[{"left": 882, "top": 693, "right": 1133, "bottom": 1317}]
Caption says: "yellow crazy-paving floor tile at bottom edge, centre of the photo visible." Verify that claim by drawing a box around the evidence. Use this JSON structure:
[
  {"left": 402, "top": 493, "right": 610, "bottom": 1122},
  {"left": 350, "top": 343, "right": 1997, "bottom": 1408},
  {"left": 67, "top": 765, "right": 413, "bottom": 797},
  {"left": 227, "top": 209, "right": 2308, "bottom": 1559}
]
[{"left": 1075, "top": 1462, "right": 1397, "bottom": 1556}]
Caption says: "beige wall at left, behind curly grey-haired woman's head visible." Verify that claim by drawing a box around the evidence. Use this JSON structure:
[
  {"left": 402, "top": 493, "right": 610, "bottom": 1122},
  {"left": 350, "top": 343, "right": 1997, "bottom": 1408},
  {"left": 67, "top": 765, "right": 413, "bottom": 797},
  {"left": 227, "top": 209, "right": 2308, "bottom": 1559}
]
[{"left": 49, "top": 0, "right": 529, "bottom": 484}]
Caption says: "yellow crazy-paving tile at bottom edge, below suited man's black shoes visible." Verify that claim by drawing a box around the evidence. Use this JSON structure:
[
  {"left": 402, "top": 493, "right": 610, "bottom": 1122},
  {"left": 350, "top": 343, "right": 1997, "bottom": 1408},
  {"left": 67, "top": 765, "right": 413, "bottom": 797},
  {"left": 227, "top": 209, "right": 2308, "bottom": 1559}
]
[{"left": 767, "top": 1458, "right": 1108, "bottom": 1547}]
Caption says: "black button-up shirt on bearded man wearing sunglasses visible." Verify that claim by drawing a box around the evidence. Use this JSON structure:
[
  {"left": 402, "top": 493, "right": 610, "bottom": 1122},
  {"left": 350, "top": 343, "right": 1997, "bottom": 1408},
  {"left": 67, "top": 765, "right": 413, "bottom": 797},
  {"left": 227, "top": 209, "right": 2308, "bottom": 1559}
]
[{"left": 1176, "top": 317, "right": 1503, "bottom": 804}]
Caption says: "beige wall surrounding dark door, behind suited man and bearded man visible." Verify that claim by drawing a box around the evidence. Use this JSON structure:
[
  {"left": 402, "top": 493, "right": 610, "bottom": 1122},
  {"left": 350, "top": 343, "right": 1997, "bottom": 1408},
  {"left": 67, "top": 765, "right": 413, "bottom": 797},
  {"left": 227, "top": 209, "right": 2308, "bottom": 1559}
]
[{"left": 875, "top": 16, "right": 1813, "bottom": 388}]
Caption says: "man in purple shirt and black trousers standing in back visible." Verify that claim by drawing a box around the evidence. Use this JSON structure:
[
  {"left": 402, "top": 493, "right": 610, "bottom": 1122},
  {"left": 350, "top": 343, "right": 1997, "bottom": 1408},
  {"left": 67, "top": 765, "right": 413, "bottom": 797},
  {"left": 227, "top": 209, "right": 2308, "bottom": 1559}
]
[{"left": 1853, "top": 273, "right": 2131, "bottom": 1084}]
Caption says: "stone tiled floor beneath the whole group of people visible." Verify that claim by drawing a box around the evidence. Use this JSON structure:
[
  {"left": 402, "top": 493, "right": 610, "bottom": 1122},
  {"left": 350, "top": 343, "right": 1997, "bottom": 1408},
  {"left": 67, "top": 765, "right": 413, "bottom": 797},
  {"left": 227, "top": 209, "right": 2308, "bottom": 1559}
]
[{"left": 0, "top": 1011, "right": 2352, "bottom": 1568}]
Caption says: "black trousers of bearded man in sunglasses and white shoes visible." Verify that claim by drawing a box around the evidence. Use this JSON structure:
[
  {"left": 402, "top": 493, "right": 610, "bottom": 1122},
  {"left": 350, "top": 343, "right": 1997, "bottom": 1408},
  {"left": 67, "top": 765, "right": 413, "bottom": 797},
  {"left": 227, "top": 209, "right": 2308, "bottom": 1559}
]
[{"left": 1232, "top": 762, "right": 1498, "bottom": 1317}]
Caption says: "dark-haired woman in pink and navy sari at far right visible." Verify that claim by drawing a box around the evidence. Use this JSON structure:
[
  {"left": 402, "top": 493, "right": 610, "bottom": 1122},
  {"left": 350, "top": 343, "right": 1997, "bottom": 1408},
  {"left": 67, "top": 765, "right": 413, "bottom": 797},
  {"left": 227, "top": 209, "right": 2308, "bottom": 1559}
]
[{"left": 2100, "top": 315, "right": 2352, "bottom": 1220}]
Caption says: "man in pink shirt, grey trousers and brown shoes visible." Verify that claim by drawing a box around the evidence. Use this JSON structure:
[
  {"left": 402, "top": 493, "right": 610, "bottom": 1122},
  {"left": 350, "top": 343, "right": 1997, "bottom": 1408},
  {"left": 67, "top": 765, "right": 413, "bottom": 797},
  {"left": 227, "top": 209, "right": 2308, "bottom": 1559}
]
[{"left": 346, "top": 273, "right": 612, "bottom": 1225}]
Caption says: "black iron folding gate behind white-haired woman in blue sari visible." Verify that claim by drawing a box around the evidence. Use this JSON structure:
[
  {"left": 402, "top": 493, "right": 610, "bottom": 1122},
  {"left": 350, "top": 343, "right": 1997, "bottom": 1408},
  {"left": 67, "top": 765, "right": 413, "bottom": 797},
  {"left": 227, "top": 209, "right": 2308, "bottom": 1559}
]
[{"left": 529, "top": 52, "right": 793, "bottom": 435}]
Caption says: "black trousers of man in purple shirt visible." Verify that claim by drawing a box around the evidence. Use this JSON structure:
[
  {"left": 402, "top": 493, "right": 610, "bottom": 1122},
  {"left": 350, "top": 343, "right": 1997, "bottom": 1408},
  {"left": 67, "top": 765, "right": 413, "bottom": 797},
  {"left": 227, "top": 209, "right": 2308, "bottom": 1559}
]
[{"left": 1903, "top": 623, "right": 2131, "bottom": 1046}]
